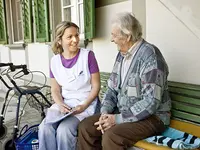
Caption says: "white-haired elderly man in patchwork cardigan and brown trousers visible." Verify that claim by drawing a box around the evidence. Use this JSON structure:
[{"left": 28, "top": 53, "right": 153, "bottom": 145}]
[{"left": 78, "top": 13, "right": 171, "bottom": 150}]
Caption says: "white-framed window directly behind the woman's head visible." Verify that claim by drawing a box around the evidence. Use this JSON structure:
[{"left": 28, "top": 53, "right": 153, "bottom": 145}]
[{"left": 61, "top": 0, "right": 84, "bottom": 39}]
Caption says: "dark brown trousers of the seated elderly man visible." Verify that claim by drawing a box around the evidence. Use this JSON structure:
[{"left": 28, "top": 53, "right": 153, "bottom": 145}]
[{"left": 77, "top": 114, "right": 165, "bottom": 150}]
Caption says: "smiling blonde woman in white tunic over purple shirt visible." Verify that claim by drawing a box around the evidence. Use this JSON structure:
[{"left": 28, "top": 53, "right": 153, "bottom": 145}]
[{"left": 39, "top": 21, "right": 100, "bottom": 150}]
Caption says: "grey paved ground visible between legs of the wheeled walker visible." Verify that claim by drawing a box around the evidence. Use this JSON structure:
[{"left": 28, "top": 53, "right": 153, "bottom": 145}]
[{"left": 0, "top": 92, "right": 41, "bottom": 150}]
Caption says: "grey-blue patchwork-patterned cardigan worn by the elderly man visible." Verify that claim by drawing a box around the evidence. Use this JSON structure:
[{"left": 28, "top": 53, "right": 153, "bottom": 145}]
[{"left": 101, "top": 40, "right": 171, "bottom": 125}]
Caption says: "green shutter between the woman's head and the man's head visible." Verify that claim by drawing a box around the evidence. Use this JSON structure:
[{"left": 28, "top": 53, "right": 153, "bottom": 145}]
[{"left": 83, "top": 0, "right": 95, "bottom": 39}]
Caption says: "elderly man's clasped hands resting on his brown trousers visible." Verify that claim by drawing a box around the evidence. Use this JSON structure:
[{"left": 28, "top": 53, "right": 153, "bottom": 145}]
[{"left": 94, "top": 114, "right": 115, "bottom": 134}]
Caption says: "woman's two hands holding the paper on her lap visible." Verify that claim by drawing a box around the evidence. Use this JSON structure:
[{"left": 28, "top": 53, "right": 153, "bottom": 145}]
[{"left": 60, "top": 103, "right": 87, "bottom": 115}]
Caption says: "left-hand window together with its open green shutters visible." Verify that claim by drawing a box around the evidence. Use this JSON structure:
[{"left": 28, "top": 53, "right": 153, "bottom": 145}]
[{"left": 0, "top": 0, "right": 50, "bottom": 44}]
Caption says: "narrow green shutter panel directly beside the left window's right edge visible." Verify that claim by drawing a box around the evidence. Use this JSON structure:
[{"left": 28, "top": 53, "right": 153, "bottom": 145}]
[{"left": 22, "top": 0, "right": 33, "bottom": 42}]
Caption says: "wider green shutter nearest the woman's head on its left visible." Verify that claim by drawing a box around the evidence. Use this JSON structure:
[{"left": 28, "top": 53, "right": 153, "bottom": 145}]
[{"left": 34, "top": 0, "right": 49, "bottom": 42}]
